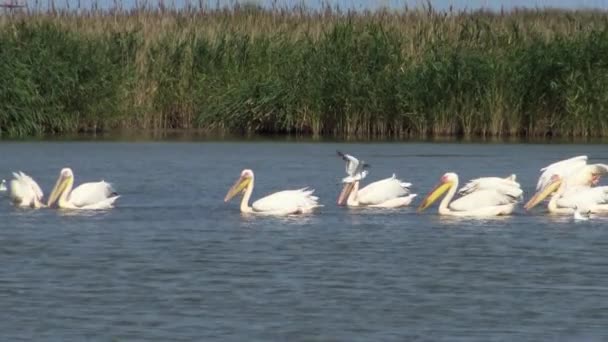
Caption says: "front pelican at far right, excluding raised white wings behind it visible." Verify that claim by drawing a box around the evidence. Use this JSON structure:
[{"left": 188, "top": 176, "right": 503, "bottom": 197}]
[{"left": 524, "top": 174, "right": 608, "bottom": 214}]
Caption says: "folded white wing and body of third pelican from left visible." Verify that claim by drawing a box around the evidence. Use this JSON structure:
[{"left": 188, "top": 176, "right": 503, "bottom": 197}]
[{"left": 251, "top": 188, "right": 319, "bottom": 213}]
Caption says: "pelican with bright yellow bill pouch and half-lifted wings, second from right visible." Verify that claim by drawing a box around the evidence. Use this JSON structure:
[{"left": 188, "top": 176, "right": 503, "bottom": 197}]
[{"left": 418, "top": 172, "right": 523, "bottom": 216}]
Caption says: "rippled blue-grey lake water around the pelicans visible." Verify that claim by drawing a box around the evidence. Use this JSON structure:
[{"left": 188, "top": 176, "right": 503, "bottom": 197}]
[{"left": 0, "top": 142, "right": 608, "bottom": 341}]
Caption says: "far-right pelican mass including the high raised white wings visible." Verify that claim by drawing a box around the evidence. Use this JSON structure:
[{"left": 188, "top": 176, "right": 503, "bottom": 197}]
[{"left": 524, "top": 156, "right": 608, "bottom": 214}]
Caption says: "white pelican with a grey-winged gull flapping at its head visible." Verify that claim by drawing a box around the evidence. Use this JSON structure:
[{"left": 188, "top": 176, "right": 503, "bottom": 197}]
[{"left": 338, "top": 151, "right": 416, "bottom": 208}]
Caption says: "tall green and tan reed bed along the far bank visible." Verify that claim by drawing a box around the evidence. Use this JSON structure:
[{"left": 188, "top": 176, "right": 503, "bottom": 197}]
[{"left": 0, "top": 2, "right": 608, "bottom": 139}]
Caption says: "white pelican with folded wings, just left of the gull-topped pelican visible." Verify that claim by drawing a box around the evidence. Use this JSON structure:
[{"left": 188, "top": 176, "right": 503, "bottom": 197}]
[{"left": 224, "top": 169, "right": 321, "bottom": 216}]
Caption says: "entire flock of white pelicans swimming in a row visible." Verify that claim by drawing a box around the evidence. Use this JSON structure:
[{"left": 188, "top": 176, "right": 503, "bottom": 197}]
[{"left": 0, "top": 151, "right": 608, "bottom": 220}]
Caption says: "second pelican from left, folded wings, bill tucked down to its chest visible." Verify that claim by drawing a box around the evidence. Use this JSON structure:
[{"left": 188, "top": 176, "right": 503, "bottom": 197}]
[{"left": 47, "top": 168, "right": 120, "bottom": 210}]
